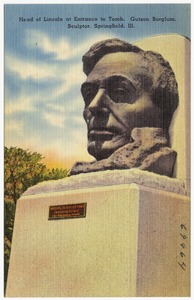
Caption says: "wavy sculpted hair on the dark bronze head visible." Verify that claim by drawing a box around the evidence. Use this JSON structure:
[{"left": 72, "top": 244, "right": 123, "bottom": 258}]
[{"left": 82, "top": 39, "right": 179, "bottom": 130}]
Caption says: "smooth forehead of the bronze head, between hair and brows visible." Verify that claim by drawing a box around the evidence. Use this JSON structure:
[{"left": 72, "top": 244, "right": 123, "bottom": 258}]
[{"left": 86, "top": 52, "right": 148, "bottom": 82}]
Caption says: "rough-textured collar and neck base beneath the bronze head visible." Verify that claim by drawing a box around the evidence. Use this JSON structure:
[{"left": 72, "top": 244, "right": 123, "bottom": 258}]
[{"left": 69, "top": 127, "right": 176, "bottom": 177}]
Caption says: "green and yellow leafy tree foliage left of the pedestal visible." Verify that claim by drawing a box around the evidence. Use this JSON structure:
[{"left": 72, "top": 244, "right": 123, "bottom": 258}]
[{"left": 4, "top": 147, "right": 68, "bottom": 294}]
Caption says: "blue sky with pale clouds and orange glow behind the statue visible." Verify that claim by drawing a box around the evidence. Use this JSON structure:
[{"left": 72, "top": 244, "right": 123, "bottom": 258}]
[{"left": 4, "top": 4, "right": 190, "bottom": 168}]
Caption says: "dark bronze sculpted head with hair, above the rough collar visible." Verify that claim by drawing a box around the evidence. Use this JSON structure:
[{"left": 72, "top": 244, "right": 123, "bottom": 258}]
[{"left": 81, "top": 39, "right": 178, "bottom": 160}]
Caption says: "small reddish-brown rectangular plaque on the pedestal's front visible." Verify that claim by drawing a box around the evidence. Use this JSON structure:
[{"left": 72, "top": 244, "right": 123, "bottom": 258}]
[{"left": 48, "top": 203, "right": 87, "bottom": 220}]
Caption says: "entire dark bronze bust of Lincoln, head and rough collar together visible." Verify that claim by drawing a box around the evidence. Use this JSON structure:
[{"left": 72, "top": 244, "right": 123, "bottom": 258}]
[{"left": 70, "top": 39, "right": 178, "bottom": 176}]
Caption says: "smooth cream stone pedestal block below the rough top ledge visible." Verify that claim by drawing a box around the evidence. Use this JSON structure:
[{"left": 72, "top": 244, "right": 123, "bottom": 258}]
[{"left": 6, "top": 170, "right": 190, "bottom": 297}]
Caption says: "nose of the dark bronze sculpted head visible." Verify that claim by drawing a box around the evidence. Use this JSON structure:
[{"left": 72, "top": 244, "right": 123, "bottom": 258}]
[{"left": 88, "top": 89, "right": 108, "bottom": 114}]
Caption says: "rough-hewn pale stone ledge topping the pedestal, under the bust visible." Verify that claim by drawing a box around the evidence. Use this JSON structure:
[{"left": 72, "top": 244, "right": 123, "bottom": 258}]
[{"left": 23, "top": 168, "right": 185, "bottom": 196}]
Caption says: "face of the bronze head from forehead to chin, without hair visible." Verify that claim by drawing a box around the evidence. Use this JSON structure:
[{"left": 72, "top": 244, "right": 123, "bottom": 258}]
[{"left": 81, "top": 52, "right": 163, "bottom": 160}]
